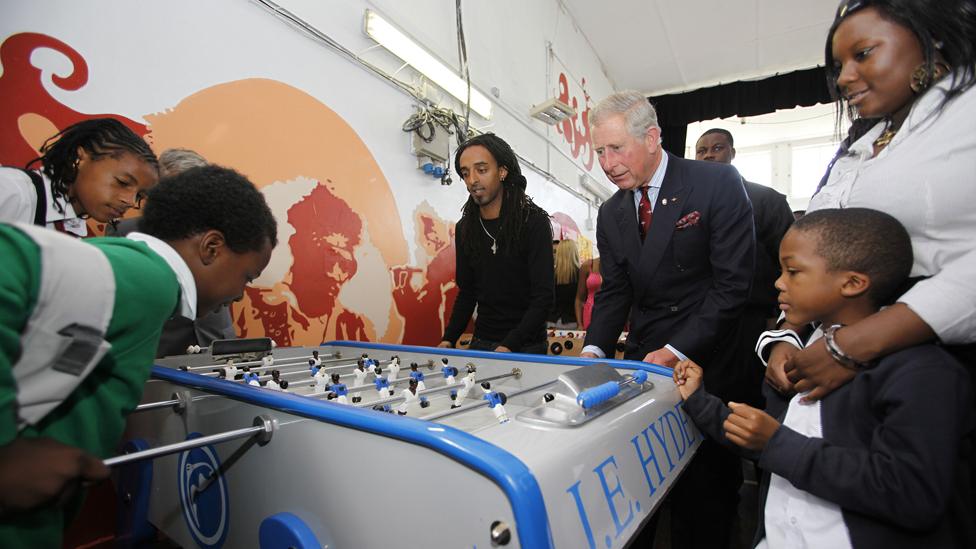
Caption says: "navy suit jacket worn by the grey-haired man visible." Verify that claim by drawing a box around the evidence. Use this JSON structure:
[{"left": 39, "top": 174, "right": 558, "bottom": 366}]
[{"left": 586, "top": 156, "right": 756, "bottom": 394}]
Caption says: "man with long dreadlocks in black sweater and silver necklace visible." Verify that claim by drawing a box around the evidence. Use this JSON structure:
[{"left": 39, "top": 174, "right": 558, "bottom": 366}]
[{"left": 440, "top": 133, "right": 553, "bottom": 354}]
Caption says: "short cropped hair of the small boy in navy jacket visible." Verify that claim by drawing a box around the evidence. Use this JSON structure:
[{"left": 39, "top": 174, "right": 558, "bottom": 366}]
[{"left": 790, "top": 208, "right": 912, "bottom": 307}]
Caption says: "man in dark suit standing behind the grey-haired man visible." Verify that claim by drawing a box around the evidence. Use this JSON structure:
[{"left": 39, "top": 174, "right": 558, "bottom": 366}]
[{"left": 695, "top": 128, "right": 793, "bottom": 409}]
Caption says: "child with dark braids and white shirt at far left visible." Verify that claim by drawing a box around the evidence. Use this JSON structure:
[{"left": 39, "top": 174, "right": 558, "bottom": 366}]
[{"left": 0, "top": 118, "right": 159, "bottom": 236}]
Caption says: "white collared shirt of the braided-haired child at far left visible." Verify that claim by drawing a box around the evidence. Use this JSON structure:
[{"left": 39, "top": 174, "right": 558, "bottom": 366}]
[{"left": 0, "top": 168, "right": 88, "bottom": 237}]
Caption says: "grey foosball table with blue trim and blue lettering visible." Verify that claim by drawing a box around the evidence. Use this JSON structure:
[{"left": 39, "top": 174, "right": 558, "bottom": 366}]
[{"left": 114, "top": 340, "right": 701, "bottom": 548}]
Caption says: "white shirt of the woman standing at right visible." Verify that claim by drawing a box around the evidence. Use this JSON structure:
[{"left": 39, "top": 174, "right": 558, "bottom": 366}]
[{"left": 807, "top": 76, "right": 976, "bottom": 344}]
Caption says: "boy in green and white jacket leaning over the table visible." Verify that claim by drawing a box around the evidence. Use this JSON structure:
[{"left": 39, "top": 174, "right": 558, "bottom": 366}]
[{"left": 0, "top": 166, "right": 277, "bottom": 548}]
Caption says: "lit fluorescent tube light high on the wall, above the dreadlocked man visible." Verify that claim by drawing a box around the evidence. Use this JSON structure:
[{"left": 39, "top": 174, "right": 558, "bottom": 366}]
[{"left": 366, "top": 10, "right": 491, "bottom": 119}]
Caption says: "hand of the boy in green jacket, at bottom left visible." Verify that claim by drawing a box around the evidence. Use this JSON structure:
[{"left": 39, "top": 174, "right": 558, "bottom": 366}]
[{"left": 0, "top": 438, "right": 109, "bottom": 515}]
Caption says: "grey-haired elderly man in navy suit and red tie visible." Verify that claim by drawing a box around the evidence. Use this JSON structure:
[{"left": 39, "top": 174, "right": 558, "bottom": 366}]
[{"left": 581, "top": 92, "right": 756, "bottom": 548}]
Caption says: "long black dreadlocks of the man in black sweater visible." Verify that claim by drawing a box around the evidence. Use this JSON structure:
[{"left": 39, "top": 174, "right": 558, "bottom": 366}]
[{"left": 454, "top": 133, "right": 549, "bottom": 262}]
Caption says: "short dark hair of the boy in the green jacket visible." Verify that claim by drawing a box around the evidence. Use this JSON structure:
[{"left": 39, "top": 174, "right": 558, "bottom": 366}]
[{"left": 139, "top": 164, "right": 278, "bottom": 253}]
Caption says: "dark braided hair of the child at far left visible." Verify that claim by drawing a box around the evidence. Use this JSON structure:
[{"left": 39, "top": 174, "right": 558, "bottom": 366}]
[{"left": 25, "top": 118, "right": 159, "bottom": 213}]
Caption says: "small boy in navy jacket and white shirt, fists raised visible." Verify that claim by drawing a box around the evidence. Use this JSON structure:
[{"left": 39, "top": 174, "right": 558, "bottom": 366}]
[{"left": 674, "top": 208, "right": 976, "bottom": 549}]
